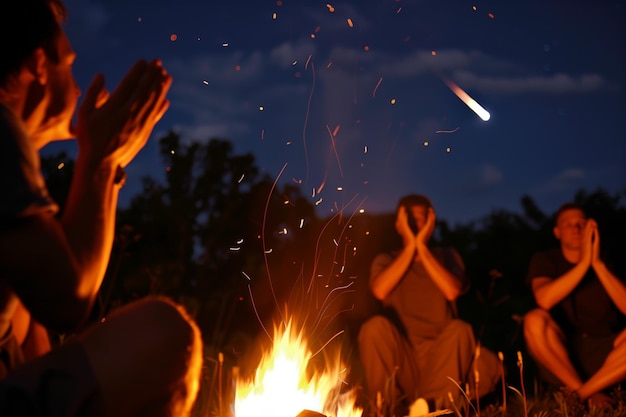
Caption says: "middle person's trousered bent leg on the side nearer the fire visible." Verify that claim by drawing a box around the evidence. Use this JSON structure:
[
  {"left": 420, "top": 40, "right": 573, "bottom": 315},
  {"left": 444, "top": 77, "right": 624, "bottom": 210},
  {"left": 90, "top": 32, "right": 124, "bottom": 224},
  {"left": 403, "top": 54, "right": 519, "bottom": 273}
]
[{"left": 359, "top": 316, "right": 419, "bottom": 401}]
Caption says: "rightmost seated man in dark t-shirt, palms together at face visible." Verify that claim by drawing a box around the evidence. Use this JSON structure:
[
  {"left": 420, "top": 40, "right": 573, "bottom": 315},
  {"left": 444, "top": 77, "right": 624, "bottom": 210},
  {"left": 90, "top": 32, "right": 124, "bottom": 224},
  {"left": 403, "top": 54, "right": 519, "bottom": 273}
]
[{"left": 524, "top": 203, "right": 626, "bottom": 407}]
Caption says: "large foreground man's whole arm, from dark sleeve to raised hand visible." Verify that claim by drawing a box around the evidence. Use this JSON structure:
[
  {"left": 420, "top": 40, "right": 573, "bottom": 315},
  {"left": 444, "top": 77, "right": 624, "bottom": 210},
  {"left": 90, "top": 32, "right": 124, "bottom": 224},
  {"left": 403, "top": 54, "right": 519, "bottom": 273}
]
[{"left": 0, "top": 61, "right": 171, "bottom": 330}]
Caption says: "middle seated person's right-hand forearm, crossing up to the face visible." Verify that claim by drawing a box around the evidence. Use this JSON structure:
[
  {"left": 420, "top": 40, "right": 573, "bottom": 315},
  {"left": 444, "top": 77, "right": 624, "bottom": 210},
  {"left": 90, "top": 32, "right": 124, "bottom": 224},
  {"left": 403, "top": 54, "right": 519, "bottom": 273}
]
[{"left": 415, "top": 208, "right": 466, "bottom": 301}]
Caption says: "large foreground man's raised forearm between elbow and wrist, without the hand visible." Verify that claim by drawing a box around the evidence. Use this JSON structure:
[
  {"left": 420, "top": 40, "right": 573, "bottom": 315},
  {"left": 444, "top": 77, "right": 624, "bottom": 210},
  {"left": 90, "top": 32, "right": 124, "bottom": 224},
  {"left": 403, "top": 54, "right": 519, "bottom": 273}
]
[{"left": 61, "top": 155, "right": 119, "bottom": 305}]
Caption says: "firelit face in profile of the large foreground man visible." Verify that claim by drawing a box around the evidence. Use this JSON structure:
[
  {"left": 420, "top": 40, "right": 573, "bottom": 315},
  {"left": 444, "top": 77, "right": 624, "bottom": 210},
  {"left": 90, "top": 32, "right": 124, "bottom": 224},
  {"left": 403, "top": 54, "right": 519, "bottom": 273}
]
[{"left": 33, "top": 31, "right": 80, "bottom": 148}]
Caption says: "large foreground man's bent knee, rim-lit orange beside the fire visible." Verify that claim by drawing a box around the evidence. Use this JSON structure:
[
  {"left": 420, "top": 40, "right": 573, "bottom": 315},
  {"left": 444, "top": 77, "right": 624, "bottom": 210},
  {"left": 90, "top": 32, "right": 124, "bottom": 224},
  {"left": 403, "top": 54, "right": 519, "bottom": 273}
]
[{"left": 80, "top": 298, "right": 202, "bottom": 417}]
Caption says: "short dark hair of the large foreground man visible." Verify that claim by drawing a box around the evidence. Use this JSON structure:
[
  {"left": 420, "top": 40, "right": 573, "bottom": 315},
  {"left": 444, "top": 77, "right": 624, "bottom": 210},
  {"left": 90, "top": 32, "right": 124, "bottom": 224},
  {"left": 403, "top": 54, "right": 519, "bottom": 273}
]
[{"left": 0, "top": 0, "right": 66, "bottom": 86}]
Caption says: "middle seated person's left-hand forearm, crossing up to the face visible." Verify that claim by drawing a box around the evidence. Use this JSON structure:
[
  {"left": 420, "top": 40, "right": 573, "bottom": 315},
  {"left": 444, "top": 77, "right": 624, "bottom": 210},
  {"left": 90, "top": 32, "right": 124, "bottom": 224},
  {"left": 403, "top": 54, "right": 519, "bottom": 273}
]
[{"left": 370, "top": 207, "right": 415, "bottom": 300}]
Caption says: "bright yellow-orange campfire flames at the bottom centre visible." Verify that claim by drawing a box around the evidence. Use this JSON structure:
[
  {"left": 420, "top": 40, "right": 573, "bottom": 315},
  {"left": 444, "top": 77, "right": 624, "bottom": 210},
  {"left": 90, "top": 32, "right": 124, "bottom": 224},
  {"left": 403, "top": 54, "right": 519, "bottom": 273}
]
[{"left": 235, "top": 322, "right": 363, "bottom": 417}]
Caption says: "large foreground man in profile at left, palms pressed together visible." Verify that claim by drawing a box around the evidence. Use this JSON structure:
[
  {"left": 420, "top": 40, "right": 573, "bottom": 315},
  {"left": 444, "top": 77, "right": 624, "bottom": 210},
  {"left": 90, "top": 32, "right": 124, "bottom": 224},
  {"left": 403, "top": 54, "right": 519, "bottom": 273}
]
[{"left": 0, "top": 0, "right": 202, "bottom": 417}]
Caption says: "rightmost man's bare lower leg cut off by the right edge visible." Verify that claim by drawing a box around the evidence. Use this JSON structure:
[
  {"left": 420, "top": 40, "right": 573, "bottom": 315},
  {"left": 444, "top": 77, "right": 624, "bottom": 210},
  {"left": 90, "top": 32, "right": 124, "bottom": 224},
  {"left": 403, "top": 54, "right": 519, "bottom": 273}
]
[{"left": 578, "top": 329, "right": 626, "bottom": 400}]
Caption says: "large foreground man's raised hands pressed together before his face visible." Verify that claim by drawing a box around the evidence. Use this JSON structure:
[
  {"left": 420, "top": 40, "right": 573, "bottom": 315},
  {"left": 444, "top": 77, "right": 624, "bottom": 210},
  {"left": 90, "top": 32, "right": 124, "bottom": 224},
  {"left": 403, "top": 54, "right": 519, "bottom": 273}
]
[{"left": 76, "top": 60, "right": 172, "bottom": 167}]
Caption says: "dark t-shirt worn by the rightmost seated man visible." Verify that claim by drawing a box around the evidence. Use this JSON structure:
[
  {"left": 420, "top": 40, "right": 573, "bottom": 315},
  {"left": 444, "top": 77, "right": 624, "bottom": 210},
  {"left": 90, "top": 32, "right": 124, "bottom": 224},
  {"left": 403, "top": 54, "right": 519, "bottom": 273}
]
[{"left": 527, "top": 248, "right": 626, "bottom": 336}]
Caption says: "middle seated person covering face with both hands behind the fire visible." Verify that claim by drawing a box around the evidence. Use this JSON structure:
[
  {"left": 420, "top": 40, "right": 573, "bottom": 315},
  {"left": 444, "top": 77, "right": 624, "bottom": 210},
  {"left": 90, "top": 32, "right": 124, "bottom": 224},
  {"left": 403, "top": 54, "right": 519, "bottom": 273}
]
[{"left": 359, "top": 194, "right": 498, "bottom": 415}]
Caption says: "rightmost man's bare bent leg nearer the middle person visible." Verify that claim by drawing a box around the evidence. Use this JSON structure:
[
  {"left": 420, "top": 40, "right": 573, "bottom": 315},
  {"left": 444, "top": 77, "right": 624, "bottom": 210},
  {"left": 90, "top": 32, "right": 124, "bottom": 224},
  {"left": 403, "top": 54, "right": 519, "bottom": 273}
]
[{"left": 524, "top": 308, "right": 583, "bottom": 391}]
